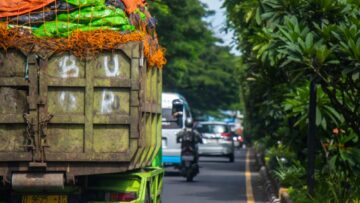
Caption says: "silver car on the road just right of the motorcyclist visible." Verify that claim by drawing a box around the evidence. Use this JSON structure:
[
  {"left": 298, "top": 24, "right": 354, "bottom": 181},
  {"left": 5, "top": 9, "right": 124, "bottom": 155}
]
[{"left": 195, "top": 122, "right": 234, "bottom": 162}]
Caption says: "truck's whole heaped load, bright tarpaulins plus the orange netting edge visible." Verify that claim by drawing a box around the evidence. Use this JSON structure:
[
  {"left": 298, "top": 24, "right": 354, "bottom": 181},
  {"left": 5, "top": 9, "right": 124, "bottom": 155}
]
[{"left": 0, "top": 0, "right": 166, "bottom": 68}]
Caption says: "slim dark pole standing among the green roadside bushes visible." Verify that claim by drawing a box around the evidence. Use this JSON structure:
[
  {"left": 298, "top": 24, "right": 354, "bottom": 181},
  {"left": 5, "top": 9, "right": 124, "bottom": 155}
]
[{"left": 307, "top": 79, "right": 316, "bottom": 195}]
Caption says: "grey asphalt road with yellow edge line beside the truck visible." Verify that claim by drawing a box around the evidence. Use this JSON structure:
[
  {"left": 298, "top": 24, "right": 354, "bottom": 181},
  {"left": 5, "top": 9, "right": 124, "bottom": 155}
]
[{"left": 162, "top": 149, "right": 266, "bottom": 203}]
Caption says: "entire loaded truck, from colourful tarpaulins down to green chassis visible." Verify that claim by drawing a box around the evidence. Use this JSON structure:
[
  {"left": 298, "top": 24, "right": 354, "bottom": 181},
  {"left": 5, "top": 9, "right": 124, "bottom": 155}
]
[{"left": 0, "top": 0, "right": 165, "bottom": 203}]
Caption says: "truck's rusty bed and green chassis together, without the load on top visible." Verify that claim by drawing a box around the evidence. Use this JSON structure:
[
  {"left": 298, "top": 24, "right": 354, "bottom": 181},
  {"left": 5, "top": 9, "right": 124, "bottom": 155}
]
[{"left": 0, "top": 0, "right": 164, "bottom": 203}]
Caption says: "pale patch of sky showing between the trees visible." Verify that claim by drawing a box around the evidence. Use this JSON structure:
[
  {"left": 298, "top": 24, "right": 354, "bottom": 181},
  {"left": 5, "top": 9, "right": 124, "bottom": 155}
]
[{"left": 200, "top": 0, "right": 240, "bottom": 55}]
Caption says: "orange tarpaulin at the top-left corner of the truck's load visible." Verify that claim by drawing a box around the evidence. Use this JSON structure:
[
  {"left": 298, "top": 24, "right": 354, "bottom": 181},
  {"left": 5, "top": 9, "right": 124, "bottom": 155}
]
[{"left": 0, "top": 0, "right": 55, "bottom": 17}]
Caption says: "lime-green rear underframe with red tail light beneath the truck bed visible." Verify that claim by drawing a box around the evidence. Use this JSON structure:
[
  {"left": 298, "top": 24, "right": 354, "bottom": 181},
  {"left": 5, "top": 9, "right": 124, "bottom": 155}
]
[{"left": 85, "top": 167, "right": 164, "bottom": 203}]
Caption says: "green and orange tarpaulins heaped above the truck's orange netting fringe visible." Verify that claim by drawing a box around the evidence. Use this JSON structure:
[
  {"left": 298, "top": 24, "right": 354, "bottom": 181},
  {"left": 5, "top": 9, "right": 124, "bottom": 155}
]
[{"left": 0, "top": 0, "right": 148, "bottom": 38}]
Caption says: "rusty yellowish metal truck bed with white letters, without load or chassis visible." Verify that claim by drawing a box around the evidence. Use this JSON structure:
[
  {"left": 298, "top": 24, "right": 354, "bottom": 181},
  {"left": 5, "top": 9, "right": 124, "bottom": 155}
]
[{"left": 0, "top": 42, "right": 162, "bottom": 177}]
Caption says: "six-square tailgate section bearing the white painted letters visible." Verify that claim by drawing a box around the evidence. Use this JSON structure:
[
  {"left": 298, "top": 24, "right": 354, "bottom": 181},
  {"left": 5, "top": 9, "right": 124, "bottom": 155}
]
[{"left": 44, "top": 50, "right": 131, "bottom": 161}]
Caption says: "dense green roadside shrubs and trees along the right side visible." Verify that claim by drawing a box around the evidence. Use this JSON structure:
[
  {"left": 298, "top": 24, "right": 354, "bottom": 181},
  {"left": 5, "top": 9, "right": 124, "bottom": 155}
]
[{"left": 224, "top": 0, "right": 360, "bottom": 203}]
